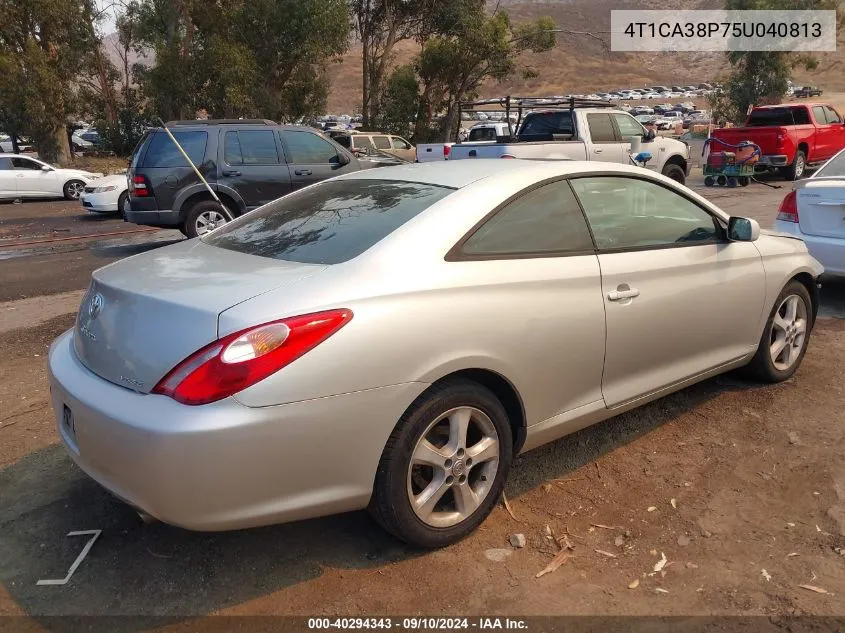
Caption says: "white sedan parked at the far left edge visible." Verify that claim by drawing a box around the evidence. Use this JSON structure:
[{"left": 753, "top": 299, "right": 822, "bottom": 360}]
[{"left": 0, "top": 154, "right": 103, "bottom": 200}]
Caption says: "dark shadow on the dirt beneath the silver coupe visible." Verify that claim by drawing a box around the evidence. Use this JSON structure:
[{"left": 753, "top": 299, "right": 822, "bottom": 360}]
[{"left": 0, "top": 366, "right": 755, "bottom": 630}]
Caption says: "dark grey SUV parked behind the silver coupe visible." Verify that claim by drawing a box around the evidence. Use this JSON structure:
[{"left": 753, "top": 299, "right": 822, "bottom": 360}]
[{"left": 124, "top": 119, "right": 377, "bottom": 237}]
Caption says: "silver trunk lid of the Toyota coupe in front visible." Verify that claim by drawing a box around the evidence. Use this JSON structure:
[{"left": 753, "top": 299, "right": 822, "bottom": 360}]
[{"left": 74, "top": 240, "right": 326, "bottom": 393}]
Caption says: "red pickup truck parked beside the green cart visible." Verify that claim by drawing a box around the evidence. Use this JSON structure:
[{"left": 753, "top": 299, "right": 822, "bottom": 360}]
[{"left": 711, "top": 103, "right": 845, "bottom": 180}]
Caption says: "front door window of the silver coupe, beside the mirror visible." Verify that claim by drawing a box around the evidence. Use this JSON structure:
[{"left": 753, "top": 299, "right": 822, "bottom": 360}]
[{"left": 572, "top": 176, "right": 721, "bottom": 250}]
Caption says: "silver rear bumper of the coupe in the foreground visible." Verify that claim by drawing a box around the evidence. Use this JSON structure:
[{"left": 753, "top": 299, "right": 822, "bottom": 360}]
[{"left": 49, "top": 331, "right": 426, "bottom": 530}]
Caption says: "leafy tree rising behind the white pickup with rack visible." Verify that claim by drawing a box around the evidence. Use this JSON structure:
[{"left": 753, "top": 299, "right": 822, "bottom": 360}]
[{"left": 414, "top": 10, "right": 556, "bottom": 142}]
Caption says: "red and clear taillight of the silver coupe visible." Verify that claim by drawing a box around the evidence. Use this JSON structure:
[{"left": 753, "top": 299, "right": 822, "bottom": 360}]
[{"left": 153, "top": 309, "right": 352, "bottom": 405}]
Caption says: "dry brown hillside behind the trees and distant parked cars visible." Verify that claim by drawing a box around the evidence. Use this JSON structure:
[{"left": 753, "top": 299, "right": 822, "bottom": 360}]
[{"left": 329, "top": 0, "right": 845, "bottom": 113}]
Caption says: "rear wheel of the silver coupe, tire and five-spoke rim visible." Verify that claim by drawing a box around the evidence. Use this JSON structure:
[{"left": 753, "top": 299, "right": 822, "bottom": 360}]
[{"left": 369, "top": 379, "right": 513, "bottom": 548}]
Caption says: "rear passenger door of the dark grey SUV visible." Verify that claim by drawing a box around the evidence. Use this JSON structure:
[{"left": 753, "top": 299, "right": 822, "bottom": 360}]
[{"left": 217, "top": 129, "right": 292, "bottom": 211}]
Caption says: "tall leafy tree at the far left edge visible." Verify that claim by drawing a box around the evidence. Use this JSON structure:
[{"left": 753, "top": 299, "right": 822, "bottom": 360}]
[{"left": 0, "top": 0, "right": 97, "bottom": 163}]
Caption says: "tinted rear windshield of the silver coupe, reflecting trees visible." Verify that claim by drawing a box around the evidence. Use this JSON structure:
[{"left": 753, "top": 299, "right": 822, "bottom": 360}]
[{"left": 203, "top": 180, "right": 454, "bottom": 264}]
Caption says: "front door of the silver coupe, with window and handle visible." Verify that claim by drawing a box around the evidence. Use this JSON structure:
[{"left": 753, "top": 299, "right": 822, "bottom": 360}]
[{"left": 571, "top": 175, "right": 766, "bottom": 408}]
